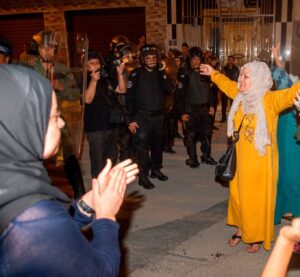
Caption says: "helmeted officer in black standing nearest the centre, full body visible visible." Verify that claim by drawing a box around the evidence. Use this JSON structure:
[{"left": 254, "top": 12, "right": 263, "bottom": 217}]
[{"left": 126, "top": 44, "right": 172, "bottom": 189}]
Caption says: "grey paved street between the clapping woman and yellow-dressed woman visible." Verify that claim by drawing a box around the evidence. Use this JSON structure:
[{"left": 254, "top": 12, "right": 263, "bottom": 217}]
[{"left": 81, "top": 117, "right": 300, "bottom": 277}]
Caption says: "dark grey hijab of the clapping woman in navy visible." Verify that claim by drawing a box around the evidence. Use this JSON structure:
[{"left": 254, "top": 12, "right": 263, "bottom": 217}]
[{"left": 0, "top": 65, "right": 69, "bottom": 233}]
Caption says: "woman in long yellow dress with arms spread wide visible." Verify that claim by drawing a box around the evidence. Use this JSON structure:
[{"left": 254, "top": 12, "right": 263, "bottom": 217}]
[{"left": 200, "top": 62, "right": 300, "bottom": 253}]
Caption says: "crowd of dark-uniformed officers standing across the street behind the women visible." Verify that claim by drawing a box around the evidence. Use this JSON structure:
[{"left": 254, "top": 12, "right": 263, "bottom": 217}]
[{"left": 0, "top": 31, "right": 239, "bottom": 190}]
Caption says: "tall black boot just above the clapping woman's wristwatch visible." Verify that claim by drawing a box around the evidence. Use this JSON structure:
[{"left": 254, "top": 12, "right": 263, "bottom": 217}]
[{"left": 64, "top": 155, "right": 85, "bottom": 199}]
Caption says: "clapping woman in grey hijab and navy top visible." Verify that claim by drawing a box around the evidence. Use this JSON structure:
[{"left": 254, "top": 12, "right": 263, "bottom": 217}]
[{"left": 0, "top": 65, "right": 138, "bottom": 276}]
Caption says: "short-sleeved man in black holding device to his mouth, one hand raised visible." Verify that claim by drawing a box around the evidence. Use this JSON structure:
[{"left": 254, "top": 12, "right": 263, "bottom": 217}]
[{"left": 84, "top": 51, "right": 126, "bottom": 178}]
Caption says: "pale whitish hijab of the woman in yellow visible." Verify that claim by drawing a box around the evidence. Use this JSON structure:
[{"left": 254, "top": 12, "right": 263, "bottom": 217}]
[{"left": 227, "top": 62, "right": 273, "bottom": 156}]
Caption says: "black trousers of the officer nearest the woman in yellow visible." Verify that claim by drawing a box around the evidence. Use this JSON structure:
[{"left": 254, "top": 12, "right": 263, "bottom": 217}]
[{"left": 184, "top": 104, "right": 212, "bottom": 161}]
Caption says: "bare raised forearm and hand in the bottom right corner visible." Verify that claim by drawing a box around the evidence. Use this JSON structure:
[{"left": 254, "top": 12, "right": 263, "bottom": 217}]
[{"left": 261, "top": 218, "right": 300, "bottom": 277}]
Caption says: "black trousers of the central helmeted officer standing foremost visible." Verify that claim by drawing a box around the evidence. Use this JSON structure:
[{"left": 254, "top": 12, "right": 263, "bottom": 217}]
[{"left": 132, "top": 113, "right": 164, "bottom": 177}]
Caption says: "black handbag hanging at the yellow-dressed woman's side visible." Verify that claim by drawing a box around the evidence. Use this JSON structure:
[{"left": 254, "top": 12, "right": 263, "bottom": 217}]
[{"left": 215, "top": 116, "right": 245, "bottom": 181}]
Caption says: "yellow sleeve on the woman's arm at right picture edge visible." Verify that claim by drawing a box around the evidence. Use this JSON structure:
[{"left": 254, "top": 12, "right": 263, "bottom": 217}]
[{"left": 266, "top": 82, "right": 300, "bottom": 114}]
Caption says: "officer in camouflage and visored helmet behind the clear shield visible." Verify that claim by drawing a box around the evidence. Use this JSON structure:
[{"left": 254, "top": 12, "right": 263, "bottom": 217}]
[{"left": 29, "top": 31, "right": 85, "bottom": 199}]
